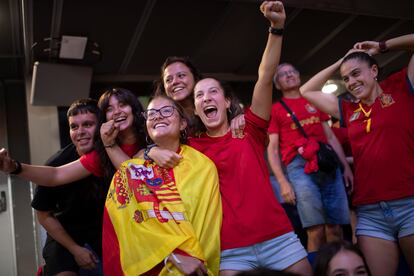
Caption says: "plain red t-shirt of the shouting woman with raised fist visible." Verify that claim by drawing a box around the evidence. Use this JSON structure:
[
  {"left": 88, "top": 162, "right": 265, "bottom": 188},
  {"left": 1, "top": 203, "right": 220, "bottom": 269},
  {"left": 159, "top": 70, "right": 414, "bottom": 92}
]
[{"left": 189, "top": 109, "right": 292, "bottom": 250}]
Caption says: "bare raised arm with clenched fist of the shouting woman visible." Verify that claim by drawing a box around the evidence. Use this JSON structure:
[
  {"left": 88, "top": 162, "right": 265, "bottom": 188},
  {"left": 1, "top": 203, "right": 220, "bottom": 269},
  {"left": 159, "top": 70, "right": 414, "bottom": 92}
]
[{"left": 251, "top": 1, "right": 286, "bottom": 120}]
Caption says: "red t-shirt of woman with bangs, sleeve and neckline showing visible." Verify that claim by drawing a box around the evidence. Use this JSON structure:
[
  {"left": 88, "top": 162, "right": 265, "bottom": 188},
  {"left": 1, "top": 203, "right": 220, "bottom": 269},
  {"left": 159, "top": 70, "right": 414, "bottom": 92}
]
[{"left": 80, "top": 144, "right": 139, "bottom": 177}]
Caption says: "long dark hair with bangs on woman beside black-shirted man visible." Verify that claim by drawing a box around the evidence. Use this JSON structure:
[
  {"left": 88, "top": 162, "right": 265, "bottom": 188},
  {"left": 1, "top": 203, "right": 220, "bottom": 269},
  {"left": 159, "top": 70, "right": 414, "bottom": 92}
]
[{"left": 96, "top": 88, "right": 145, "bottom": 181}]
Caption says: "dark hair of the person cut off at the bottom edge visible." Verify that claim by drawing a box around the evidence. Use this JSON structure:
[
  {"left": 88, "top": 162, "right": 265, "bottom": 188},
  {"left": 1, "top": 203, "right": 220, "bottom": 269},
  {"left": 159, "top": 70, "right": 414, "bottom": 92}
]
[{"left": 314, "top": 241, "right": 371, "bottom": 276}]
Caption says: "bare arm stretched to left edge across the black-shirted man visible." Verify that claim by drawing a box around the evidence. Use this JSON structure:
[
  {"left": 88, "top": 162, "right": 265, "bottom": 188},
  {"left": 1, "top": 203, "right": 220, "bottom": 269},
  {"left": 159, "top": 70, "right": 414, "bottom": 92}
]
[{"left": 0, "top": 148, "right": 90, "bottom": 186}]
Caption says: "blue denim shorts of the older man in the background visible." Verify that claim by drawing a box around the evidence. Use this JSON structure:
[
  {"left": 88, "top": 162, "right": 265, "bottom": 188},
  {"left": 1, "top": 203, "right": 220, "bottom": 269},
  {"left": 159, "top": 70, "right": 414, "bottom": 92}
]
[{"left": 286, "top": 155, "right": 349, "bottom": 228}]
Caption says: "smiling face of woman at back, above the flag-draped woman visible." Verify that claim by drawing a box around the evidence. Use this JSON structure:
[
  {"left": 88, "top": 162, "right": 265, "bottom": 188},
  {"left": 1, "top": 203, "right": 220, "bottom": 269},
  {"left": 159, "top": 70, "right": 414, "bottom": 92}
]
[{"left": 163, "top": 62, "right": 194, "bottom": 102}]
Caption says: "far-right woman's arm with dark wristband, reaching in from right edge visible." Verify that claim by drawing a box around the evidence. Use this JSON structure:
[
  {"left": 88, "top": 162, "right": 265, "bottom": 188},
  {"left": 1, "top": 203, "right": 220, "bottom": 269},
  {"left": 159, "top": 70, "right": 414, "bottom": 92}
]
[{"left": 354, "top": 34, "right": 414, "bottom": 84}]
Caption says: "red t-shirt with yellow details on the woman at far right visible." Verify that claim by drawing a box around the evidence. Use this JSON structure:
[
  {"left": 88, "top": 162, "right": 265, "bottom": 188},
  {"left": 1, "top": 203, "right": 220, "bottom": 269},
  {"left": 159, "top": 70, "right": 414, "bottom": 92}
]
[{"left": 341, "top": 69, "right": 414, "bottom": 205}]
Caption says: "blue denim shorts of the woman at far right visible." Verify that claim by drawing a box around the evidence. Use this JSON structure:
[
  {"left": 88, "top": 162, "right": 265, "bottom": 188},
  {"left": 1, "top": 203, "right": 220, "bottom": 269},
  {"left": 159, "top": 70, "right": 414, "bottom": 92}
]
[{"left": 356, "top": 196, "right": 414, "bottom": 241}]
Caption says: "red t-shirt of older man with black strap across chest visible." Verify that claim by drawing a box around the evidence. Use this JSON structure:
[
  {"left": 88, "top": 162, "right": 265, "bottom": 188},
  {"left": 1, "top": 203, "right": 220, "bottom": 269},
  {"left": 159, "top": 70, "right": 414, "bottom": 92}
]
[{"left": 268, "top": 97, "right": 329, "bottom": 166}]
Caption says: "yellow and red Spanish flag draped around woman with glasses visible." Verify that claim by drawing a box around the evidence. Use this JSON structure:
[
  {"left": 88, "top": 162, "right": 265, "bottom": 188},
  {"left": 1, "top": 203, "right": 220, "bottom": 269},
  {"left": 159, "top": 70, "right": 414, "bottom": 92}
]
[{"left": 102, "top": 145, "right": 222, "bottom": 276}]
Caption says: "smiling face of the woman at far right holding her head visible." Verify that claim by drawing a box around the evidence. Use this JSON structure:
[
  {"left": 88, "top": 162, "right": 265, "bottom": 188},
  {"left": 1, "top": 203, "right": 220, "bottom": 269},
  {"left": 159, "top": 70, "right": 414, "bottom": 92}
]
[{"left": 340, "top": 58, "right": 378, "bottom": 100}]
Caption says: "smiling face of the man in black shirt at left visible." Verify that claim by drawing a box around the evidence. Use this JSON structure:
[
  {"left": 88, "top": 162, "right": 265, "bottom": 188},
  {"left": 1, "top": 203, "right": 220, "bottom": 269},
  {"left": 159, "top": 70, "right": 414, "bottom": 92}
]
[{"left": 68, "top": 112, "right": 98, "bottom": 155}]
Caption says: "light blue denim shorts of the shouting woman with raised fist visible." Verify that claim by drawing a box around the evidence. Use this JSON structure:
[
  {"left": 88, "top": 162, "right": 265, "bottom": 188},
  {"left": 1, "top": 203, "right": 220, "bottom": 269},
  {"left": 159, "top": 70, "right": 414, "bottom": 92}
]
[{"left": 220, "top": 232, "right": 307, "bottom": 271}]
